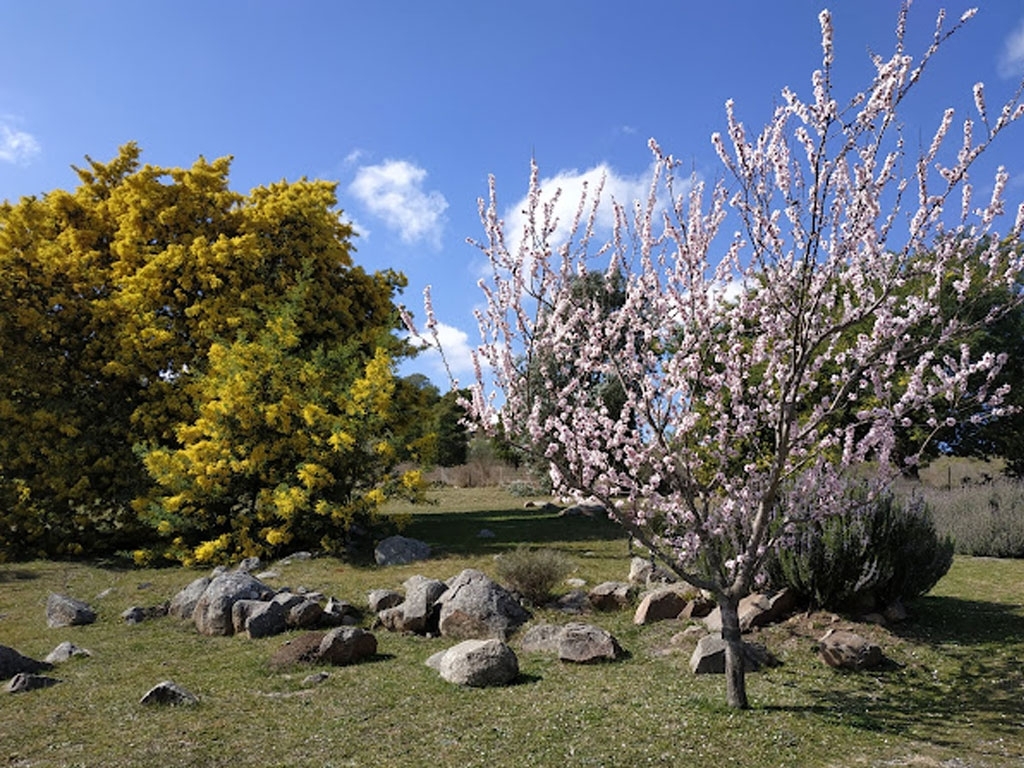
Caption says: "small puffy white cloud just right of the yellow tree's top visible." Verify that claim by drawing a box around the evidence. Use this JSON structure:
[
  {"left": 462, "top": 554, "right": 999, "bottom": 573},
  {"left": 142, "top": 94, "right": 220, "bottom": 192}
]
[{"left": 348, "top": 160, "right": 449, "bottom": 248}]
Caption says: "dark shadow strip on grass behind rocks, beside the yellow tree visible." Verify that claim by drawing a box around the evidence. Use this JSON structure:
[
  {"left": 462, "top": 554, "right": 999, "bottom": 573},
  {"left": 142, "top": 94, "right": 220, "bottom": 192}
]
[{"left": 403, "top": 509, "right": 626, "bottom": 555}]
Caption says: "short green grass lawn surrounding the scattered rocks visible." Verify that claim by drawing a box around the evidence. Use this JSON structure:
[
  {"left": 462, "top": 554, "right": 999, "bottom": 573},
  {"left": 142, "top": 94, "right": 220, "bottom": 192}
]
[{"left": 0, "top": 489, "right": 1024, "bottom": 768}]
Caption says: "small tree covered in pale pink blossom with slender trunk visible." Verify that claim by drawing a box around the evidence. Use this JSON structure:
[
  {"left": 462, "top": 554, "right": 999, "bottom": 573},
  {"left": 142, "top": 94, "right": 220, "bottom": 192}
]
[{"left": 415, "top": 8, "right": 1024, "bottom": 708}]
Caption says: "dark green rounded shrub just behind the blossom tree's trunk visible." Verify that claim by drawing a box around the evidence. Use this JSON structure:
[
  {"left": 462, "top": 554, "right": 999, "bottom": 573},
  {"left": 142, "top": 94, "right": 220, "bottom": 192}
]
[{"left": 768, "top": 492, "right": 953, "bottom": 609}]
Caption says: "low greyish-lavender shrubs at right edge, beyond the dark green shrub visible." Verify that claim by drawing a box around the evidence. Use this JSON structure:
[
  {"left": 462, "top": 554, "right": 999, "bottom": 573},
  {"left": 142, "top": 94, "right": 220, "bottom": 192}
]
[{"left": 925, "top": 480, "right": 1024, "bottom": 557}]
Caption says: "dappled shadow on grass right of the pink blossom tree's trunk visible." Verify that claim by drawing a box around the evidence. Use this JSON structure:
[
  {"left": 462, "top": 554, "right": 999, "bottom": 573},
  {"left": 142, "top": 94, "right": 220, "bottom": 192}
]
[{"left": 766, "top": 597, "right": 1024, "bottom": 750}]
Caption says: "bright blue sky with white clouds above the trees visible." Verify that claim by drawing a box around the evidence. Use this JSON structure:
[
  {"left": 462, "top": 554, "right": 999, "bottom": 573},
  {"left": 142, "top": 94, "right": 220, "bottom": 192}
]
[{"left": 0, "top": 0, "right": 1024, "bottom": 383}]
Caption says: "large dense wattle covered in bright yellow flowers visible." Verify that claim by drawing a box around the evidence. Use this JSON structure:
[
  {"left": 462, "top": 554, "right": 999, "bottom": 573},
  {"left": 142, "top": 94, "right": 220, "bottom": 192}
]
[{"left": 0, "top": 144, "right": 417, "bottom": 560}]
